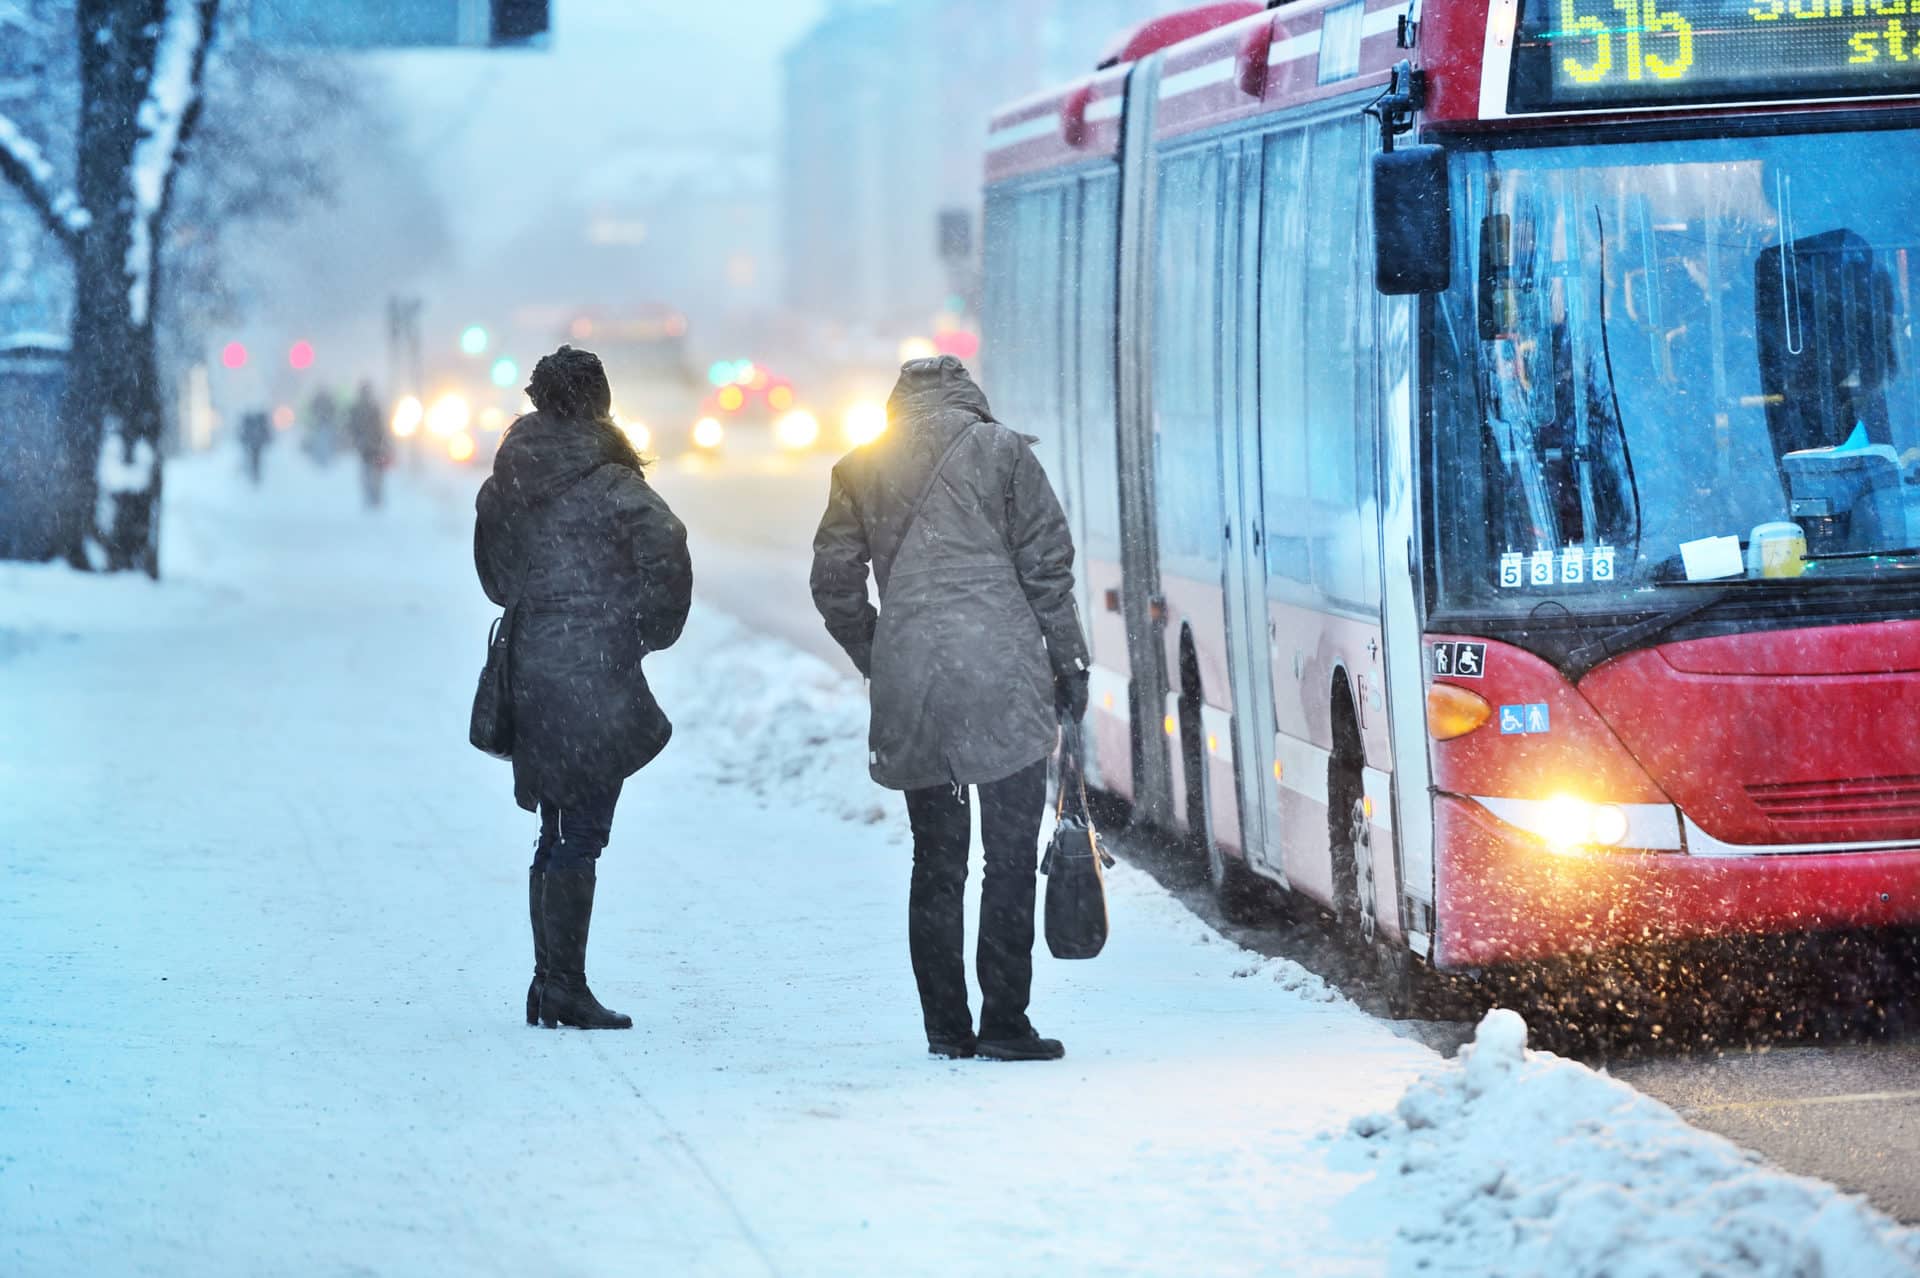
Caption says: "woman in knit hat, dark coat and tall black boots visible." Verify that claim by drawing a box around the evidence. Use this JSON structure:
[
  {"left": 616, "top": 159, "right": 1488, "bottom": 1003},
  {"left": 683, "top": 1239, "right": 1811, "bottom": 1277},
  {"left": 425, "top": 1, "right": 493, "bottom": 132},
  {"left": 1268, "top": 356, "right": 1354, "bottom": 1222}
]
[{"left": 474, "top": 345, "right": 693, "bottom": 1029}]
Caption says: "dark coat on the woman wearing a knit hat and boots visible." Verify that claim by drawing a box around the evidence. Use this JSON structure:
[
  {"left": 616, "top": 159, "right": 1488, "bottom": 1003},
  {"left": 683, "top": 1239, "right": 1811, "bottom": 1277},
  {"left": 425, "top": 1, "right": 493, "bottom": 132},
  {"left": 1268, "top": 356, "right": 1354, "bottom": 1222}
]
[{"left": 474, "top": 413, "right": 693, "bottom": 808}]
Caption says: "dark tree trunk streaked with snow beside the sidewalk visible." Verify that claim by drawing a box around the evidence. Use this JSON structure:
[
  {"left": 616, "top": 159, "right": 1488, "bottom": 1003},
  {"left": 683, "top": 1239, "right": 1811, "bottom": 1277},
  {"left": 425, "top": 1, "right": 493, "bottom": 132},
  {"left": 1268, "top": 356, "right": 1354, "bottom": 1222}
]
[{"left": 0, "top": 0, "right": 221, "bottom": 576}]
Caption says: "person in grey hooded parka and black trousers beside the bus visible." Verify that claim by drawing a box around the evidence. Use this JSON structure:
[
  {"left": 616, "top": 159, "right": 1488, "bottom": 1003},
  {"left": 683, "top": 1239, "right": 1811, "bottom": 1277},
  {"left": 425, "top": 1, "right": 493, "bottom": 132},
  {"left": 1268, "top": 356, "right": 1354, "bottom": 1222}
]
[{"left": 812, "top": 355, "right": 1089, "bottom": 1059}]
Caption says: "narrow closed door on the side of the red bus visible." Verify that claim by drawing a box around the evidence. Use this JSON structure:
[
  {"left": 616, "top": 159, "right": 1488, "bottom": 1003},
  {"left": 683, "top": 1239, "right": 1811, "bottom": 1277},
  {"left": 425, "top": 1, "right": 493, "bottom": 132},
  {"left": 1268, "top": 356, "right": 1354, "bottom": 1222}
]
[{"left": 1213, "top": 138, "right": 1284, "bottom": 883}]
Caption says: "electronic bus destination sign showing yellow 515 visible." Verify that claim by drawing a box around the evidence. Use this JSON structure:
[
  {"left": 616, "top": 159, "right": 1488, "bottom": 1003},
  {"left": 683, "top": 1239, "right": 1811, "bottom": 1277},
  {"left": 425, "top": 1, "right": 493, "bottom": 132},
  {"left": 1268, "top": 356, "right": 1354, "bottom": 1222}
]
[{"left": 1507, "top": 0, "right": 1920, "bottom": 113}]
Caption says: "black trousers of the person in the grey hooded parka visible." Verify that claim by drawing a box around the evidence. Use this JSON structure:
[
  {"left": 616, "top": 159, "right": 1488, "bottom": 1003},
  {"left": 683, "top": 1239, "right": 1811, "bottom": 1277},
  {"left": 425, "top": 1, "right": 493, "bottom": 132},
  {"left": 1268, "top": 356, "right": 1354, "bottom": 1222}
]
[{"left": 906, "top": 760, "right": 1046, "bottom": 1040}]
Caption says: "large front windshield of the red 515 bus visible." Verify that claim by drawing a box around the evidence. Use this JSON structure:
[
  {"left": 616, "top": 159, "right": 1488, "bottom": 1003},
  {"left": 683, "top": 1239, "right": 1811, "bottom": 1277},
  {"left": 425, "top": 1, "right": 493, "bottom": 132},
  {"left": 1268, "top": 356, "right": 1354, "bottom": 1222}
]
[{"left": 1428, "top": 121, "right": 1920, "bottom": 614}]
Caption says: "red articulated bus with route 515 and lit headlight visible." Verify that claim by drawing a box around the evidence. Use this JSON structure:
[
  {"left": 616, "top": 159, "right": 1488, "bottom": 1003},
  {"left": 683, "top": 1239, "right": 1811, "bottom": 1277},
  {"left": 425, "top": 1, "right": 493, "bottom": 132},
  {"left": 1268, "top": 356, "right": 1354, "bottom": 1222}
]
[{"left": 985, "top": 0, "right": 1920, "bottom": 981}]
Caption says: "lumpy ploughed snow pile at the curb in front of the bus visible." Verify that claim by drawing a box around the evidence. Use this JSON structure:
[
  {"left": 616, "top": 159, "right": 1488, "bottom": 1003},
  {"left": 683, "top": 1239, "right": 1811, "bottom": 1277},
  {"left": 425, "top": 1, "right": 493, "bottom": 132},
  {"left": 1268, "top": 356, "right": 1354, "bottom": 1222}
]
[{"left": 1336, "top": 1009, "right": 1920, "bottom": 1278}]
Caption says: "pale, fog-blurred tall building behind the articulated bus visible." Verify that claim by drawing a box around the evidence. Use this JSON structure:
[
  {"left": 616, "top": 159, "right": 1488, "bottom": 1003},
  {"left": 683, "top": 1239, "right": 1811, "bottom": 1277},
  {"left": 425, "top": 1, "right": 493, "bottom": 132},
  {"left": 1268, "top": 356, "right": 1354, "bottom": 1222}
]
[{"left": 780, "top": 0, "right": 1171, "bottom": 336}]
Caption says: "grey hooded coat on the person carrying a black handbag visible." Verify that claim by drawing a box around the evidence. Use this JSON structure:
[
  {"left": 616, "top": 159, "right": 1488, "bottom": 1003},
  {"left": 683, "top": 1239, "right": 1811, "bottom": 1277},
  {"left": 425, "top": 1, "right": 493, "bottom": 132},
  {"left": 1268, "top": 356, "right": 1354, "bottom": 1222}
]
[{"left": 812, "top": 357, "right": 1087, "bottom": 791}]
